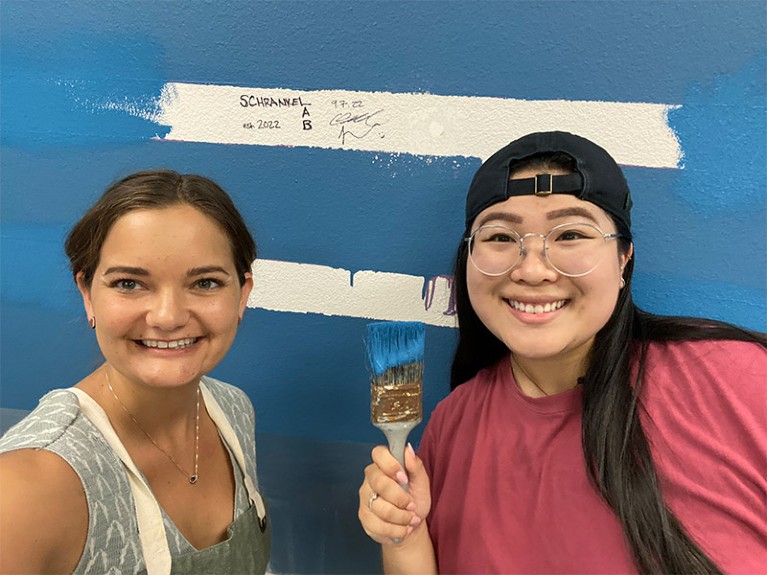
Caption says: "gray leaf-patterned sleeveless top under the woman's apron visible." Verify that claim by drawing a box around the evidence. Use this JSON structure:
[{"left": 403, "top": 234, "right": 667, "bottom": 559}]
[{"left": 0, "top": 377, "right": 258, "bottom": 575}]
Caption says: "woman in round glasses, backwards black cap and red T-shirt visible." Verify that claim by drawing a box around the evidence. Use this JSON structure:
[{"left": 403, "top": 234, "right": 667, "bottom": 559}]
[{"left": 359, "top": 132, "right": 767, "bottom": 573}]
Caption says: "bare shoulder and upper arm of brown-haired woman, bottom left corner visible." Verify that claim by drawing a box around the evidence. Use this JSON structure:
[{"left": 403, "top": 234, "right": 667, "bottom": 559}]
[{"left": 0, "top": 449, "right": 88, "bottom": 572}]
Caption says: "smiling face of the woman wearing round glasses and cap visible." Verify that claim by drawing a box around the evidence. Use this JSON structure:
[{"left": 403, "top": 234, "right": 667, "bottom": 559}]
[{"left": 466, "top": 170, "right": 631, "bottom": 362}]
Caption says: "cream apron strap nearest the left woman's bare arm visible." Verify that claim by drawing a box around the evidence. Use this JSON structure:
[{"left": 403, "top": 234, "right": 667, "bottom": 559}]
[{"left": 69, "top": 387, "right": 171, "bottom": 575}]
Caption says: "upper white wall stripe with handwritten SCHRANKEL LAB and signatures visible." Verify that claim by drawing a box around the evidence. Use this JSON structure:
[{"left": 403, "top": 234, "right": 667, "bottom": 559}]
[{"left": 152, "top": 82, "right": 682, "bottom": 168}]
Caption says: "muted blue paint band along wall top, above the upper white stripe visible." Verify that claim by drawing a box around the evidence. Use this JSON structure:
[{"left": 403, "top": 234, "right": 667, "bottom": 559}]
[{"left": 0, "top": 0, "right": 765, "bottom": 109}]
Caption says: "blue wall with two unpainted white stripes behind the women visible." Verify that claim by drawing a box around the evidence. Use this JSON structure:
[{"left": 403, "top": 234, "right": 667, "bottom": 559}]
[{"left": 0, "top": 0, "right": 767, "bottom": 572}]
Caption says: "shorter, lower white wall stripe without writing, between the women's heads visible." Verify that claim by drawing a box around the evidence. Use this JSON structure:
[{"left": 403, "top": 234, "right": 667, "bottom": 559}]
[{"left": 248, "top": 260, "right": 456, "bottom": 327}]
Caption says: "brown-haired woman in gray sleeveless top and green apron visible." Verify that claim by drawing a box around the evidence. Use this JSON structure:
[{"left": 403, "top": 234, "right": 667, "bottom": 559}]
[{"left": 0, "top": 170, "right": 271, "bottom": 575}]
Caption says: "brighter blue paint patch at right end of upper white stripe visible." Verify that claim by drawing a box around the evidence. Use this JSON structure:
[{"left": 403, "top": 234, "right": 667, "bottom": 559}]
[{"left": 669, "top": 51, "right": 767, "bottom": 212}]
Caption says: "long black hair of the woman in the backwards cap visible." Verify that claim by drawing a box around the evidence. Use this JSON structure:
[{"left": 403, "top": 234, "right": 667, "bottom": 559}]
[{"left": 451, "top": 156, "right": 767, "bottom": 574}]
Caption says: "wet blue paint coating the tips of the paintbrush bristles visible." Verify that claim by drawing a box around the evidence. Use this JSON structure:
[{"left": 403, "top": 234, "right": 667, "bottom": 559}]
[{"left": 365, "top": 321, "right": 426, "bottom": 377}]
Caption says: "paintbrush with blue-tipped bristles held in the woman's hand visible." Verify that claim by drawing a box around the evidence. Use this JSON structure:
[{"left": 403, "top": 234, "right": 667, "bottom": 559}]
[{"left": 365, "top": 321, "right": 426, "bottom": 491}]
